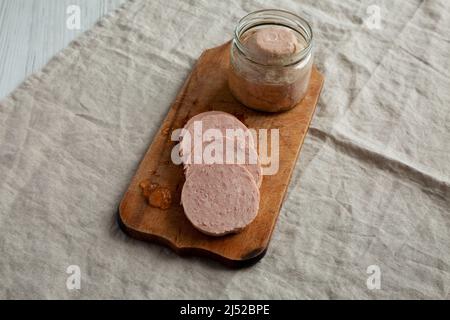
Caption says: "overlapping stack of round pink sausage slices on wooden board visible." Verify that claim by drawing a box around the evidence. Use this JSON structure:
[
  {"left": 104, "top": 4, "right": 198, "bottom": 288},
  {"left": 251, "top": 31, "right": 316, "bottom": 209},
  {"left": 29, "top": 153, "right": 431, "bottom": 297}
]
[{"left": 179, "top": 111, "right": 263, "bottom": 236}]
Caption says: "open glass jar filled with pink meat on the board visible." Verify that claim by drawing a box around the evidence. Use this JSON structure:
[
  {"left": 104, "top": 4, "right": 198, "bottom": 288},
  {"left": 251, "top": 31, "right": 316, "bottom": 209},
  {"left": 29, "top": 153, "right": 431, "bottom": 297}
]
[{"left": 228, "top": 10, "right": 313, "bottom": 112}]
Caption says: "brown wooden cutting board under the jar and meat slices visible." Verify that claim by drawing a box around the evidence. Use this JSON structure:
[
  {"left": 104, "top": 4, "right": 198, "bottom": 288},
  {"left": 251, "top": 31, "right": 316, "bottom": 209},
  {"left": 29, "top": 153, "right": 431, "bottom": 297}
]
[{"left": 119, "top": 42, "right": 324, "bottom": 267}]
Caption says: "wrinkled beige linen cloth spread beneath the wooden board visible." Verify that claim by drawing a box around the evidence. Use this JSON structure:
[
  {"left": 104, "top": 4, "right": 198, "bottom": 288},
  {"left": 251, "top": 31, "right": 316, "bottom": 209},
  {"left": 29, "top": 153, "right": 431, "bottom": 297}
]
[{"left": 0, "top": 0, "right": 450, "bottom": 299}]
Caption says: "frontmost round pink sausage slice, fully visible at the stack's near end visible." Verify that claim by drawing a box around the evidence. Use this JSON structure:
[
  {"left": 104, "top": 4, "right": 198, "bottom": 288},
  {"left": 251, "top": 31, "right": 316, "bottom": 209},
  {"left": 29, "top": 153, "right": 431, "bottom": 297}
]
[{"left": 181, "top": 165, "right": 259, "bottom": 236}]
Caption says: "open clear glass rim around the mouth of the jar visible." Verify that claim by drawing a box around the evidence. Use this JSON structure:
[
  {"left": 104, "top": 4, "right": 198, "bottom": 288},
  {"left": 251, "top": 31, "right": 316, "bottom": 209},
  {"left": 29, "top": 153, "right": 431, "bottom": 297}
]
[{"left": 233, "top": 9, "right": 313, "bottom": 66}]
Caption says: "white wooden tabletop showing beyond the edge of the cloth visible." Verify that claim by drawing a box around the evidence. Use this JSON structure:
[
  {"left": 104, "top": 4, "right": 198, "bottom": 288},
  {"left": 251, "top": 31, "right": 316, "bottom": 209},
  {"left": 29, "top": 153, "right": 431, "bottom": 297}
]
[{"left": 0, "top": 0, "right": 126, "bottom": 99}]
